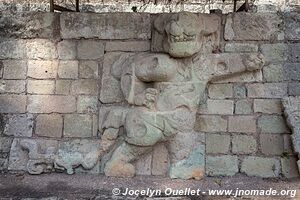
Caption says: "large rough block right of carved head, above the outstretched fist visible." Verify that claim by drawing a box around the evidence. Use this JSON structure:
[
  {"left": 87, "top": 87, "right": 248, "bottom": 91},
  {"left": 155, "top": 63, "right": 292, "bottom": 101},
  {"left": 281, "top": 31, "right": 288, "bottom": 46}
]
[{"left": 224, "top": 13, "right": 282, "bottom": 40}]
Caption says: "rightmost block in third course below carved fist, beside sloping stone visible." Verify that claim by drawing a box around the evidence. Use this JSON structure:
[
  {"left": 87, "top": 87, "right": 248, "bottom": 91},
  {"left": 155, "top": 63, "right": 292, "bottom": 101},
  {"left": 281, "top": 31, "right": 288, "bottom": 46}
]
[{"left": 257, "top": 115, "right": 290, "bottom": 133}]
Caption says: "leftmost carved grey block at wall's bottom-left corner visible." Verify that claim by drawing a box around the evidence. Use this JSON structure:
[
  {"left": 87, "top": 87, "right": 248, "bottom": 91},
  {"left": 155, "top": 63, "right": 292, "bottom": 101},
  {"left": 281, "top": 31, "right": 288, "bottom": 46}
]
[{"left": 8, "top": 138, "right": 58, "bottom": 174}]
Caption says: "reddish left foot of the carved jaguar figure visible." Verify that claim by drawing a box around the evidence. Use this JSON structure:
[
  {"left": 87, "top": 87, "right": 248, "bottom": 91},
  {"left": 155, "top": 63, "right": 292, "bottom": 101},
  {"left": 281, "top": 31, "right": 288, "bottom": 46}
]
[{"left": 104, "top": 161, "right": 135, "bottom": 178}]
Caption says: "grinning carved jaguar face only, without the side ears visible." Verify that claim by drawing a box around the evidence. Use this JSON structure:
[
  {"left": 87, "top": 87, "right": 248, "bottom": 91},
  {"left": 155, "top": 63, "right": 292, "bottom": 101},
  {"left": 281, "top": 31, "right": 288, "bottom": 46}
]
[{"left": 164, "top": 12, "right": 201, "bottom": 58}]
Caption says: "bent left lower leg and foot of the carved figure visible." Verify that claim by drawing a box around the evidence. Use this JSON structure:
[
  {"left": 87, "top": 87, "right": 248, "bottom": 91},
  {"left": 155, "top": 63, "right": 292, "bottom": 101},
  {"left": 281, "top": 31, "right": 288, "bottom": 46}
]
[{"left": 104, "top": 142, "right": 151, "bottom": 177}]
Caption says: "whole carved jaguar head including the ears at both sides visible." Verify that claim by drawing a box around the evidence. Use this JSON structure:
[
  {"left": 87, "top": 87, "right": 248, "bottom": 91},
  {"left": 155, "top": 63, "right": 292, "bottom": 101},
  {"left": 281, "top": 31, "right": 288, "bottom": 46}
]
[{"left": 152, "top": 12, "right": 218, "bottom": 58}]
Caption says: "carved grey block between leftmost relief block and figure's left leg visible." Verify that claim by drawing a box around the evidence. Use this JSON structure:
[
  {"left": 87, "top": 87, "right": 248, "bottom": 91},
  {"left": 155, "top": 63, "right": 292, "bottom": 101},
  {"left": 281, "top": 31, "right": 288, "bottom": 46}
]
[{"left": 54, "top": 139, "right": 100, "bottom": 174}]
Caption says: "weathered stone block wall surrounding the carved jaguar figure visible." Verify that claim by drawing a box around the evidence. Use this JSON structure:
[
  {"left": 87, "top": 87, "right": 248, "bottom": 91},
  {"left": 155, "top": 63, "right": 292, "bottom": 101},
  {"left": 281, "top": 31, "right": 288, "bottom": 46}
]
[{"left": 0, "top": 12, "right": 300, "bottom": 178}]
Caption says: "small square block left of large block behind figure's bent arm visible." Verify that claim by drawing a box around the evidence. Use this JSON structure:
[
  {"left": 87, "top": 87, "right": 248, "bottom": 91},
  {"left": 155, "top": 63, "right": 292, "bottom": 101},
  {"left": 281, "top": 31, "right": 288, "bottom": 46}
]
[{"left": 79, "top": 60, "right": 99, "bottom": 79}]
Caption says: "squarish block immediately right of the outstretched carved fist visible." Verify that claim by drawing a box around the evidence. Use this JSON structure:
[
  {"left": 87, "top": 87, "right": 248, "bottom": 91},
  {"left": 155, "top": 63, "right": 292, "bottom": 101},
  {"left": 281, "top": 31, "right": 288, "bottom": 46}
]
[{"left": 261, "top": 43, "right": 287, "bottom": 63}]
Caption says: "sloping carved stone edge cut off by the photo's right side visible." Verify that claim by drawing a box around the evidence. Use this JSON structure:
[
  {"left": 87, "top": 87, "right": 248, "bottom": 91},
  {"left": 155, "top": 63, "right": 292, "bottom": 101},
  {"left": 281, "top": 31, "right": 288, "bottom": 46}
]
[{"left": 282, "top": 97, "right": 300, "bottom": 172}]
